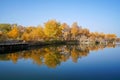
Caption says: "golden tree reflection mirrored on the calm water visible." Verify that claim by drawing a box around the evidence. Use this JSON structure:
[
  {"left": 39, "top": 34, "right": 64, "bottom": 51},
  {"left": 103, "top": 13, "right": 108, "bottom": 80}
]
[{"left": 0, "top": 44, "right": 116, "bottom": 68}]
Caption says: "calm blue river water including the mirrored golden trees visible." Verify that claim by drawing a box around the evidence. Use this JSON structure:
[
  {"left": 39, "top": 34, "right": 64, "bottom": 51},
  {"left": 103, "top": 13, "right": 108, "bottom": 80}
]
[{"left": 0, "top": 44, "right": 120, "bottom": 80}]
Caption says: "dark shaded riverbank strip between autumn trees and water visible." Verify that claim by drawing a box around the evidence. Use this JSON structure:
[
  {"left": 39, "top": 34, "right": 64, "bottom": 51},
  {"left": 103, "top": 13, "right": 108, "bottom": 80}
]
[{"left": 0, "top": 40, "right": 118, "bottom": 53}]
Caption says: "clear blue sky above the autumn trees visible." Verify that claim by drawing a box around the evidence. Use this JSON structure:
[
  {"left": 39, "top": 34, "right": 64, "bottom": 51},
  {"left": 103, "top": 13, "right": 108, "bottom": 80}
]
[{"left": 0, "top": 0, "right": 120, "bottom": 37}]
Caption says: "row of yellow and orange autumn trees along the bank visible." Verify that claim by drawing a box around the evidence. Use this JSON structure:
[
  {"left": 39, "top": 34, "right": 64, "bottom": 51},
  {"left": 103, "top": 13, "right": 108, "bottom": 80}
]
[{"left": 0, "top": 20, "right": 117, "bottom": 41}]
